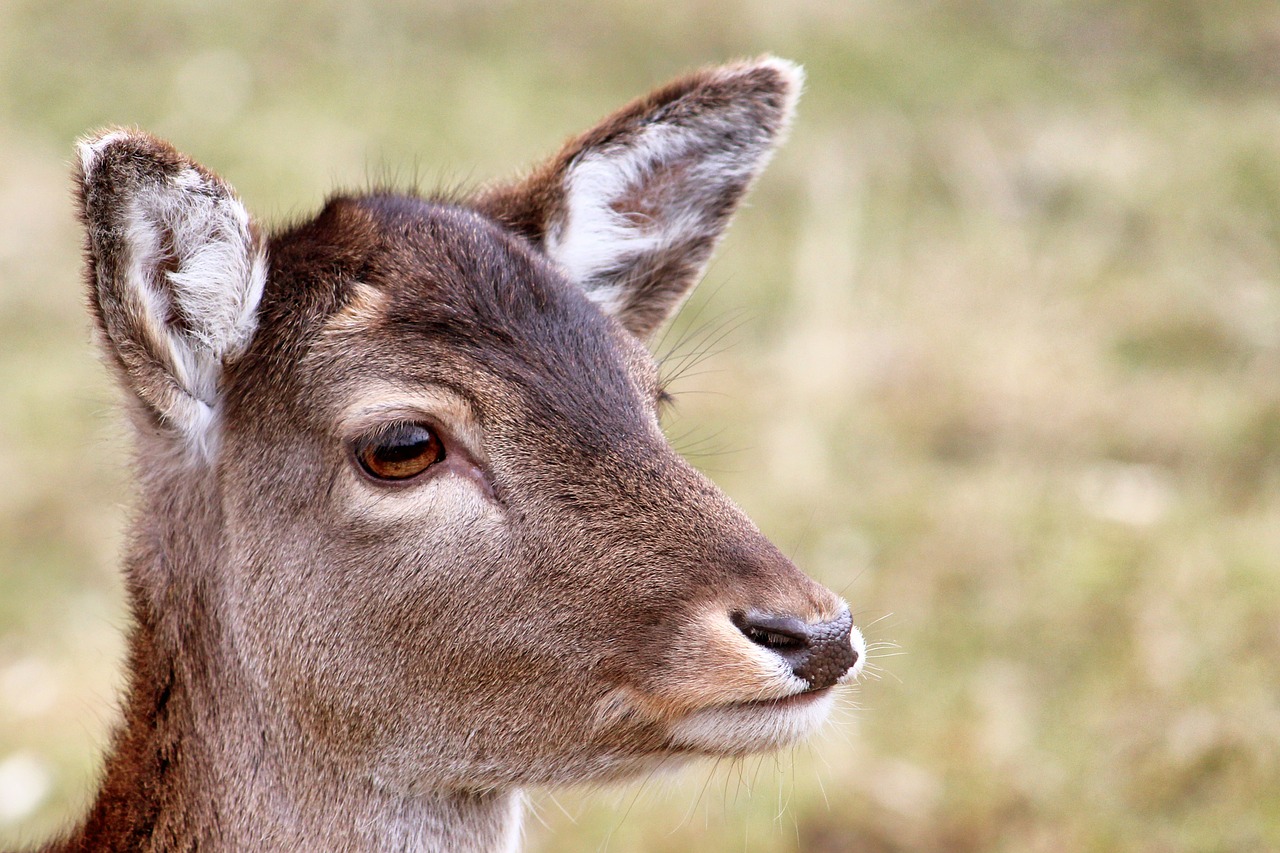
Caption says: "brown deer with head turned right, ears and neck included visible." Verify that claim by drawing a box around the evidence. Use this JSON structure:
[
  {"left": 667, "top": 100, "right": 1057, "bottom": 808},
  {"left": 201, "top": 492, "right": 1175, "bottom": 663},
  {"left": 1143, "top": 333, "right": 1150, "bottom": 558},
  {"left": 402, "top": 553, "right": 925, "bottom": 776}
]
[{"left": 30, "top": 56, "right": 867, "bottom": 853}]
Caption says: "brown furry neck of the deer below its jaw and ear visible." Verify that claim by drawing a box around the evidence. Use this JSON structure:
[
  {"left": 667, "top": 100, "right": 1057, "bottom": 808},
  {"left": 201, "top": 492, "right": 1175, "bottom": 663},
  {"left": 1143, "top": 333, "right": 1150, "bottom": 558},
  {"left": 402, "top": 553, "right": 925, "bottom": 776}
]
[{"left": 62, "top": 469, "right": 522, "bottom": 853}]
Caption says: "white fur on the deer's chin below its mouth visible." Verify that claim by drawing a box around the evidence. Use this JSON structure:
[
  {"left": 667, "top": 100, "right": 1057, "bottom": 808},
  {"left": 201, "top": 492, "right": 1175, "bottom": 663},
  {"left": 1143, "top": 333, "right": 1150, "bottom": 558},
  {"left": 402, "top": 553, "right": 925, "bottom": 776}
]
[{"left": 672, "top": 690, "right": 836, "bottom": 754}]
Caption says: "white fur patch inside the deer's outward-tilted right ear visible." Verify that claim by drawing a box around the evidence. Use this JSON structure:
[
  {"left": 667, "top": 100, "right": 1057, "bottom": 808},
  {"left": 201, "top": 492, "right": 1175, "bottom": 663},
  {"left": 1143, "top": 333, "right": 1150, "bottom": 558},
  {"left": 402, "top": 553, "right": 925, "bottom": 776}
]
[{"left": 547, "top": 122, "right": 763, "bottom": 314}]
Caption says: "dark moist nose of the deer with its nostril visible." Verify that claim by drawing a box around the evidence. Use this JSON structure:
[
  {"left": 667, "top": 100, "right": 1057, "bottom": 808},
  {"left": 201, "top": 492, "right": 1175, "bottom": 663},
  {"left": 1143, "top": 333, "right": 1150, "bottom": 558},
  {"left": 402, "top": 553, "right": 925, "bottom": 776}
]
[{"left": 731, "top": 610, "right": 858, "bottom": 690}]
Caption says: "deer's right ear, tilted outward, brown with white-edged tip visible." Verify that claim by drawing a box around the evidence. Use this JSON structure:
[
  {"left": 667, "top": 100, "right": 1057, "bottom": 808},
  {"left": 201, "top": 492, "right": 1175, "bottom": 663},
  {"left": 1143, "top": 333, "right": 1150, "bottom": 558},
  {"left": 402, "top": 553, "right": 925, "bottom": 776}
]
[{"left": 477, "top": 58, "right": 803, "bottom": 338}]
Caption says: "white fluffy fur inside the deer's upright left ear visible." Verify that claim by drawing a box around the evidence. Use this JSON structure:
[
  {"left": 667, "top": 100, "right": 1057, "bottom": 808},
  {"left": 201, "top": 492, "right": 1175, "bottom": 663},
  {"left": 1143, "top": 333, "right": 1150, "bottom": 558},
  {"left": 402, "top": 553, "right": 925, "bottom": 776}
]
[{"left": 124, "top": 169, "right": 266, "bottom": 457}]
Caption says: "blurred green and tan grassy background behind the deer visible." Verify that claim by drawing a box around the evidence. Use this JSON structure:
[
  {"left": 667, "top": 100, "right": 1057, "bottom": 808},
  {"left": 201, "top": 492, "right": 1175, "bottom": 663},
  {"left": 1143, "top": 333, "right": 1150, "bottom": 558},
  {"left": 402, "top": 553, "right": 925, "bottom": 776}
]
[{"left": 0, "top": 0, "right": 1280, "bottom": 852}]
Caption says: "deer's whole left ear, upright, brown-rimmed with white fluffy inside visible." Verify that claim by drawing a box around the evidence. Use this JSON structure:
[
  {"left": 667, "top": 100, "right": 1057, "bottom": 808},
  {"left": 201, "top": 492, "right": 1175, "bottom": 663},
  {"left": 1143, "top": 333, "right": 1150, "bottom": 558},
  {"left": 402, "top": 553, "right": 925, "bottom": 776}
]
[{"left": 76, "top": 131, "right": 266, "bottom": 453}]
